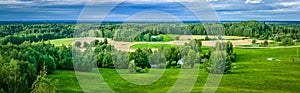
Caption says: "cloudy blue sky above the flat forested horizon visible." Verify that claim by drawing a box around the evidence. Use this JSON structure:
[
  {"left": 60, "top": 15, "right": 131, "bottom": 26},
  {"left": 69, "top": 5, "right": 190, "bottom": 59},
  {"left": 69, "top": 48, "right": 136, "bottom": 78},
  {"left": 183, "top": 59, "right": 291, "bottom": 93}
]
[{"left": 0, "top": 0, "right": 300, "bottom": 21}]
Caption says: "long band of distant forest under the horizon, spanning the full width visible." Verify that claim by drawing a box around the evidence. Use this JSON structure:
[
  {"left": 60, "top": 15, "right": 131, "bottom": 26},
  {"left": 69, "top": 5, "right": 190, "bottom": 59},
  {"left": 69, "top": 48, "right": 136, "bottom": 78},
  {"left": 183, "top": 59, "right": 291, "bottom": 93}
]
[{"left": 0, "top": 21, "right": 300, "bottom": 45}]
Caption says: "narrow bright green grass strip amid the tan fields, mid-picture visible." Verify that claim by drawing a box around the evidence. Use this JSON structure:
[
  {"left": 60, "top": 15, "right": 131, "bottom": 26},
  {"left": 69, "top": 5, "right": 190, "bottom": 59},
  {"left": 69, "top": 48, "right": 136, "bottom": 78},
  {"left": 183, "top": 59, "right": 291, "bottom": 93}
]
[{"left": 130, "top": 43, "right": 176, "bottom": 49}]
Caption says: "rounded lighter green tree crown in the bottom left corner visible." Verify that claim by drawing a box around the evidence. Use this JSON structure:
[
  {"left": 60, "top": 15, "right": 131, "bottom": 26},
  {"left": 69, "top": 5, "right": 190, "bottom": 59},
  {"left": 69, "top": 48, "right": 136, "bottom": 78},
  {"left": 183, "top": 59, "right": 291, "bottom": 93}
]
[{"left": 0, "top": 59, "right": 36, "bottom": 93}]
